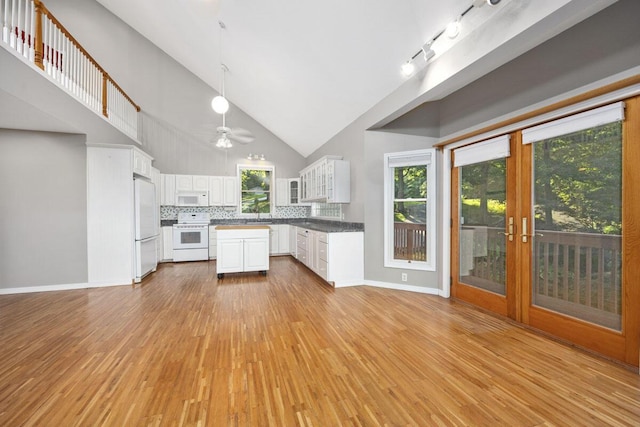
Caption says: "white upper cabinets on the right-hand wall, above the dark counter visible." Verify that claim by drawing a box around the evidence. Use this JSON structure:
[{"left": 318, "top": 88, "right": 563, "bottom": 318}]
[{"left": 300, "top": 156, "right": 351, "bottom": 203}]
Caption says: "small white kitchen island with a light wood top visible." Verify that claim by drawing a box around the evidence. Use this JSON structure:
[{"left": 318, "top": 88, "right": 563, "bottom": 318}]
[{"left": 216, "top": 225, "right": 270, "bottom": 279}]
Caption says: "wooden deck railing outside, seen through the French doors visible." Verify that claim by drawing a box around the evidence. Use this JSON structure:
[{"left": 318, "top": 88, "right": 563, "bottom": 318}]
[{"left": 464, "top": 226, "right": 622, "bottom": 325}]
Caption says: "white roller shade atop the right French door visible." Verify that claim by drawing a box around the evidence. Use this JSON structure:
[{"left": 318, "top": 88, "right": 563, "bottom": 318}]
[{"left": 522, "top": 102, "right": 624, "bottom": 144}]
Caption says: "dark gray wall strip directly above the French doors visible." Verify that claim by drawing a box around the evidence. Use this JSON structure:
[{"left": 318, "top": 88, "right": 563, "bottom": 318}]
[{"left": 438, "top": 0, "right": 640, "bottom": 136}]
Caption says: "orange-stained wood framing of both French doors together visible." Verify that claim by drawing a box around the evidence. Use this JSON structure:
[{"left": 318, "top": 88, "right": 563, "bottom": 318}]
[{"left": 450, "top": 96, "right": 640, "bottom": 367}]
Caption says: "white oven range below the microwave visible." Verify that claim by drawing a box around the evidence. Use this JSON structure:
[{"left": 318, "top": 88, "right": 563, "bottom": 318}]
[{"left": 173, "top": 212, "right": 210, "bottom": 262}]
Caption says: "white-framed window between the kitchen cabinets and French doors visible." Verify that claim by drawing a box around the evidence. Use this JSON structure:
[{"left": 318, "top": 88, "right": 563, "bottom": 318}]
[{"left": 384, "top": 149, "right": 436, "bottom": 270}]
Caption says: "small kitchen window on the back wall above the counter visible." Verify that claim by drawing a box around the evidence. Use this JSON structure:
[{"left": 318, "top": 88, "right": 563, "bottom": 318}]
[{"left": 238, "top": 165, "right": 273, "bottom": 216}]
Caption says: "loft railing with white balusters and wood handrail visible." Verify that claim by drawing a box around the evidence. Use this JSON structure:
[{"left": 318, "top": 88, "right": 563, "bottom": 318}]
[{"left": 0, "top": 0, "right": 140, "bottom": 139}]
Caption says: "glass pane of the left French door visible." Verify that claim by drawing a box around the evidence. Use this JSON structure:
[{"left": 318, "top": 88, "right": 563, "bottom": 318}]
[{"left": 458, "top": 159, "right": 507, "bottom": 295}]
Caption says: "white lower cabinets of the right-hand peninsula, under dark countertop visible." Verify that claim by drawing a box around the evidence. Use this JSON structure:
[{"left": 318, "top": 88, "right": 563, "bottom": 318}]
[{"left": 296, "top": 227, "right": 364, "bottom": 287}]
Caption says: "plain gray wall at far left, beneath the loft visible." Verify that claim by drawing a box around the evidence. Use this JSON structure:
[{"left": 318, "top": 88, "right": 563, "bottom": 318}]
[{"left": 0, "top": 129, "right": 88, "bottom": 289}]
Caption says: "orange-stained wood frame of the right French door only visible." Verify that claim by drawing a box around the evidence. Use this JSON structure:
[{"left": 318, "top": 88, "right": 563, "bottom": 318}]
[{"left": 518, "top": 97, "right": 640, "bottom": 366}]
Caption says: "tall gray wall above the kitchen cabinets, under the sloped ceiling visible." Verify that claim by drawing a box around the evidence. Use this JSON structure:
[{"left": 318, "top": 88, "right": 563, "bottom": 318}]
[{"left": 46, "top": 0, "right": 306, "bottom": 178}]
